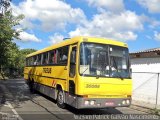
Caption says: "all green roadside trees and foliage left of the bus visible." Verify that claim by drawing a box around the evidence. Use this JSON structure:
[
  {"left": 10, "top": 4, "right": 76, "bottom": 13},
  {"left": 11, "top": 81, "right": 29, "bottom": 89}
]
[{"left": 0, "top": 1, "right": 36, "bottom": 79}]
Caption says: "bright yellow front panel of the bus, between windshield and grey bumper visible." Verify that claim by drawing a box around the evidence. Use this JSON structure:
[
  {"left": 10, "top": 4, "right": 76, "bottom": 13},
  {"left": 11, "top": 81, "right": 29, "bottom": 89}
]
[{"left": 77, "top": 77, "right": 132, "bottom": 98}]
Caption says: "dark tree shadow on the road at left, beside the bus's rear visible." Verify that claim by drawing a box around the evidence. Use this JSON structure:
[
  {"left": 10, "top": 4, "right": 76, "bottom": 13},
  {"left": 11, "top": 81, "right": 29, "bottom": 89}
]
[{"left": 0, "top": 79, "right": 39, "bottom": 108}]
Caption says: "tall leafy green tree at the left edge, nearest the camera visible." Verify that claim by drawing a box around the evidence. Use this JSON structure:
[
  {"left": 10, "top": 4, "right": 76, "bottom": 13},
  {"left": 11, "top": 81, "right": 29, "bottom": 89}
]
[{"left": 0, "top": 0, "right": 24, "bottom": 78}]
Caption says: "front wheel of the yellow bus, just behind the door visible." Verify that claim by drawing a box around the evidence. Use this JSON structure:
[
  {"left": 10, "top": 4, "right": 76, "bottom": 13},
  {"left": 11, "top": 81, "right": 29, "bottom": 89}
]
[{"left": 57, "top": 89, "right": 65, "bottom": 109}]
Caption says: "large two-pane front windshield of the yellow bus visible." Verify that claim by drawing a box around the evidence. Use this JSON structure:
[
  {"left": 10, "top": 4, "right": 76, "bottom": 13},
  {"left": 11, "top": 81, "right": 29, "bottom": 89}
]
[{"left": 80, "top": 43, "right": 130, "bottom": 79}]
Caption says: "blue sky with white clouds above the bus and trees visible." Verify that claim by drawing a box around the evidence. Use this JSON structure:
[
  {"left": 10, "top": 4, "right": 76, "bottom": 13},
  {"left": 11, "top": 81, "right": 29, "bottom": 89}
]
[{"left": 12, "top": 0, "right": 160, "bottom": 52}]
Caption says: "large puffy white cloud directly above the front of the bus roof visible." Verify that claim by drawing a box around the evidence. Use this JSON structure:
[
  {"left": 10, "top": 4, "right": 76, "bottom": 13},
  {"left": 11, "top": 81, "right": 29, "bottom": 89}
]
[{"left": 69, "top": 11, "right": 143, "bottom": 41}]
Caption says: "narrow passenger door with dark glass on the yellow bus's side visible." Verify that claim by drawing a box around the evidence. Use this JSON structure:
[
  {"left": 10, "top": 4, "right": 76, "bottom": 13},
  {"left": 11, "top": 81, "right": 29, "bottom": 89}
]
[{"left": 68, "top": 45, "right": 77, "bottom": 96}]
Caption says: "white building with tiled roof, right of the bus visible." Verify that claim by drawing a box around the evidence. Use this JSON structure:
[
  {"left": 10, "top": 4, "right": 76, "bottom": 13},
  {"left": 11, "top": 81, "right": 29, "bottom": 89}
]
[{"left": 130, "top": 48, "right": 160, "bottom": 107}]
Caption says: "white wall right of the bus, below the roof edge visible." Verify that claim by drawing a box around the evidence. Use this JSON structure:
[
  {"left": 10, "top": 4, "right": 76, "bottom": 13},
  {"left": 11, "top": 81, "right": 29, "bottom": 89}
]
[{"left": 131, "top": 57, "right": 160, "bottom": 106}]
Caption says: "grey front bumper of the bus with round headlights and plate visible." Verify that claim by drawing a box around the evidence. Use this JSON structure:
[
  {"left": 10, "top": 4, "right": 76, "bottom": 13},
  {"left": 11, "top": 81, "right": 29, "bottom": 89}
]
[{"left": 67, "top": 96, "right": 131, "bottom": 109}]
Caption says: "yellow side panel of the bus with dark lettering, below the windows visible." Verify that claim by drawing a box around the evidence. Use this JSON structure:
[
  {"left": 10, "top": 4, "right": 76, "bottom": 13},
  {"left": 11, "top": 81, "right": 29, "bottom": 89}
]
[{"left": 24, "top": 66, "right": 68, "bottom": 91}]
